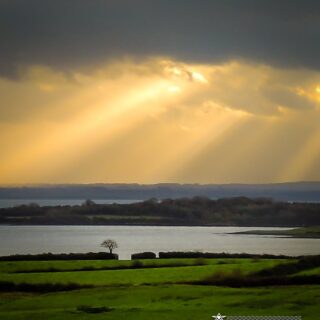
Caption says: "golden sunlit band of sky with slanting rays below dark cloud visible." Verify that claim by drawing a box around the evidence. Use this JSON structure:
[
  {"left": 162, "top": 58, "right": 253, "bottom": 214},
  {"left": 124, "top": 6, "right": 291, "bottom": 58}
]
[{"left": 0, "top": 58, "right": 320, "bottom": 183}]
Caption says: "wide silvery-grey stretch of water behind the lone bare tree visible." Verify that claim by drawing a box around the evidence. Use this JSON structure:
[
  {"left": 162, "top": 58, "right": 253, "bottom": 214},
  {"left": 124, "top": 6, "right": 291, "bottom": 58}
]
[{"left": 0, "top": 225, "right": 320, "bottom": 259}]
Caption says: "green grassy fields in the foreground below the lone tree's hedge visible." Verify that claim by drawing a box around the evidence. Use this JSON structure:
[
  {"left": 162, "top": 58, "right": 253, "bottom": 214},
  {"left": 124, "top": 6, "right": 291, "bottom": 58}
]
[{"left": 0, "top": 258, "right": 320, "bottom": 320}]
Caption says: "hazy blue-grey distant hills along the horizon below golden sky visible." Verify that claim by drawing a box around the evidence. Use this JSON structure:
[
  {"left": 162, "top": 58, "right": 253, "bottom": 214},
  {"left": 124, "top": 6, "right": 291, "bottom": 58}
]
[{"left": 0, "top": 182, "right": 320, "bottom": 202}]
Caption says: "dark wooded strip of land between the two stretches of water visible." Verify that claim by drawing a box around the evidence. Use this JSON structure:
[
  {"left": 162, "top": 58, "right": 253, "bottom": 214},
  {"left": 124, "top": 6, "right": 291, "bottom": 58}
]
[{"left": 0, "top": 197, "right": 320, "bottom": 227}]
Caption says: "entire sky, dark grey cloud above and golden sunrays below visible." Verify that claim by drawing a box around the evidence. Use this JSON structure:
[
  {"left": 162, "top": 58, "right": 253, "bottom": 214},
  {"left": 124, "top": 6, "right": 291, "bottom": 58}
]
[{"left": 0, "top": 0, "right": 320, "bottom": 185}]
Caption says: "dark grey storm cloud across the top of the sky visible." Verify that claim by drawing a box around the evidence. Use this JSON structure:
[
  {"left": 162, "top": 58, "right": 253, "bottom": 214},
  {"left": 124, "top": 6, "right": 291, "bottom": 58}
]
[{"left": 0, "top": 0, "right": 320, "bottom": 75}]
